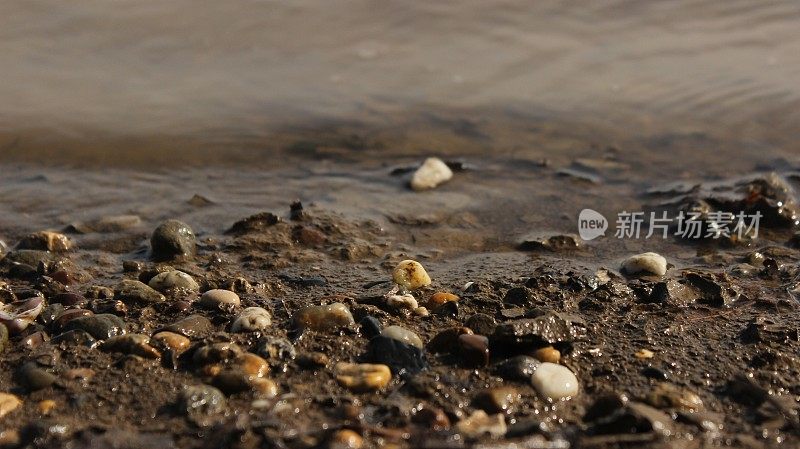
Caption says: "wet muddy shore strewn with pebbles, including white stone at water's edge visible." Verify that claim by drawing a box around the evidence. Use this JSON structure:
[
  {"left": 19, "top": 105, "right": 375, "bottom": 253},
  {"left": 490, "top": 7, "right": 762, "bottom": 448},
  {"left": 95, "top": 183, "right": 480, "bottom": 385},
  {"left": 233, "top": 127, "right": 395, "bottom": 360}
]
[{"left": 0, "top": 192, "right": 800, "bottom": 448}]
